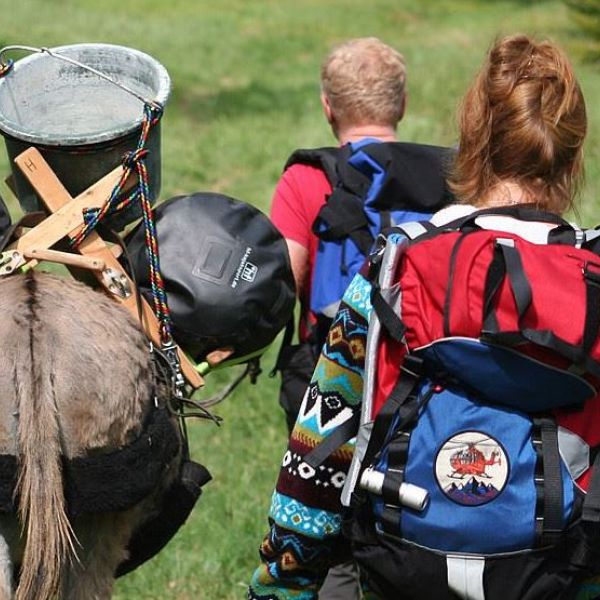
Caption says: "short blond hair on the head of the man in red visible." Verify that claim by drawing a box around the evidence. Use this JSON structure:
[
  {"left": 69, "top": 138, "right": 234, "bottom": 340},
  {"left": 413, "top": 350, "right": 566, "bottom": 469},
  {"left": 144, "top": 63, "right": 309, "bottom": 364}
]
[{"left": 321, "top": 37, "right": 406, "bottom": 127}]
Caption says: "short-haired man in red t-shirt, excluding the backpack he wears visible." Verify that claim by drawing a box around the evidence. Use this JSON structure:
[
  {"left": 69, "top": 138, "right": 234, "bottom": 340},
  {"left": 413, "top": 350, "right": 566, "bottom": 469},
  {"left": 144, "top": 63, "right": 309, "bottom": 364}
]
[{"left": 271, "top": 37, "right": 406, "bottom": 440}]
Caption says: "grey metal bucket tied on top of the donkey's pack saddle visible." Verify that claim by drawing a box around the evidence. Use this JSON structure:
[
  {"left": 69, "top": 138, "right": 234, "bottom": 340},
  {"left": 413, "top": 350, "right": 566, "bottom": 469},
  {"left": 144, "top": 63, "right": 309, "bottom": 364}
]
[{"left": 0, "top": 44, "right": 171, "bottom": 230}]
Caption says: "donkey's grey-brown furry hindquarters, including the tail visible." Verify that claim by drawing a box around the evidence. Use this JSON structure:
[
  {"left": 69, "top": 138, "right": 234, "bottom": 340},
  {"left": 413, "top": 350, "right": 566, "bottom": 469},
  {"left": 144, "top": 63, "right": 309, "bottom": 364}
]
[{"left": 0, "top": 272, "right": 178, "bottom": 600}]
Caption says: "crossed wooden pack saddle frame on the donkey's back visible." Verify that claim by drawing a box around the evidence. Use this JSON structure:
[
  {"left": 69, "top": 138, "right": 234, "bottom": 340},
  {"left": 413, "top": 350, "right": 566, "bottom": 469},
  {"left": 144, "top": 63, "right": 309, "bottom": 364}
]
[{"left": 5, "top": 148, "right": 204, "bottom": 389}]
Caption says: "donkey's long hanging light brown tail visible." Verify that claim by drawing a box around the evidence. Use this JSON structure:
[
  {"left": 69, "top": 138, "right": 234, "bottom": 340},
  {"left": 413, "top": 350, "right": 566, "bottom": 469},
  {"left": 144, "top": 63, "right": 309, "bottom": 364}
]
[{"left": 15, "top": 274, "right": 76, "bottom": 600}]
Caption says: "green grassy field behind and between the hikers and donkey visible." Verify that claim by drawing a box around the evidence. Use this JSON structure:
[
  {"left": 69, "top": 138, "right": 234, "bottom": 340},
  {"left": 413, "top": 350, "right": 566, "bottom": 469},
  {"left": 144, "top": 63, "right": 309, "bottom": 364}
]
[{"left": 0, "top": 0, "right": 600, "bottom": 600}]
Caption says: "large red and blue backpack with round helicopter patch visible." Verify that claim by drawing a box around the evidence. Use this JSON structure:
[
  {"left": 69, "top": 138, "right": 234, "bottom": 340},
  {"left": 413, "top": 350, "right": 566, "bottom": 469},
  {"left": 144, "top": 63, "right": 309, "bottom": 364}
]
[{"left": 344, "top": 206, "right": 600, "bottom": 600}]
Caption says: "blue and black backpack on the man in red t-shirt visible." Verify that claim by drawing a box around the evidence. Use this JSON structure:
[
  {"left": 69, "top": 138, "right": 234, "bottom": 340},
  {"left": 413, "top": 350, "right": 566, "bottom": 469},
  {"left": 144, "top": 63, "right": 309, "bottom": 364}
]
[{"left": 285, "top": 138, "right": 451, "bottom": 324}]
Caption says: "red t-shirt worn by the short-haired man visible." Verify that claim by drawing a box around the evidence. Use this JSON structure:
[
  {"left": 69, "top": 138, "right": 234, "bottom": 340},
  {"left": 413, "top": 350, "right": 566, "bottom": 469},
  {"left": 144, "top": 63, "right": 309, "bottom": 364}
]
[{"left": 271, "top": 163, "right": 331, "bottom": 340}]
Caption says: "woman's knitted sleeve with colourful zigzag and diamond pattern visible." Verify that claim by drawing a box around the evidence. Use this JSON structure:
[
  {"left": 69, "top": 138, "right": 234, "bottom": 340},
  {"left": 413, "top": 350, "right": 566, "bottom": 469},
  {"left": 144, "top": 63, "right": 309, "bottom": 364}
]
[{"left": 248, "top": 274, "right": 371, "bottom": 600}]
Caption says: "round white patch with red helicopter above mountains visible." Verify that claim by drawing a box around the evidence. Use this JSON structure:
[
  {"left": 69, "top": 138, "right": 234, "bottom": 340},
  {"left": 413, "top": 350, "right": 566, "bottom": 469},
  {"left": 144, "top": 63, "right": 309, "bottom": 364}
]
[{"left": 434, "top": 431, "right": 510, "bottom": 506}]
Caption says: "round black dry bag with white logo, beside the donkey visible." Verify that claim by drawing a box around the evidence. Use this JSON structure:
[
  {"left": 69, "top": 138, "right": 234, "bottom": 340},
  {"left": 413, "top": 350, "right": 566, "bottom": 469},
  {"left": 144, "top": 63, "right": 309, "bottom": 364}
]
[{"left": 126, "top": 192, "right": 295, "bottom": 361}]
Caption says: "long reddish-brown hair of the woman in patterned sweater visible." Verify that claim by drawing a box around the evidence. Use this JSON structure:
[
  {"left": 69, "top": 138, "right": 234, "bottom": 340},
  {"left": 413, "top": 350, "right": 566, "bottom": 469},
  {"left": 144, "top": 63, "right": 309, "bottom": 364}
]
[{"left": 449, "top": 35, "right": 587, "bottom": 214}]
